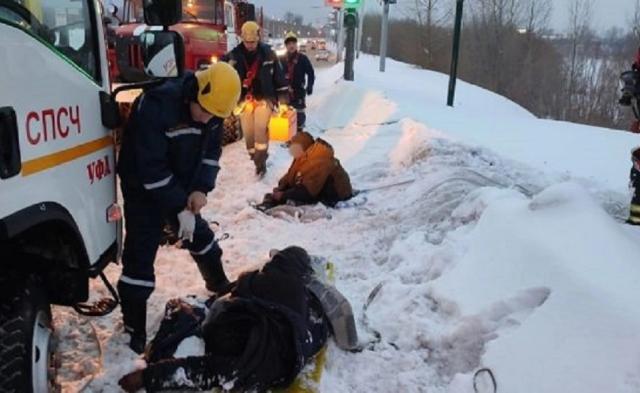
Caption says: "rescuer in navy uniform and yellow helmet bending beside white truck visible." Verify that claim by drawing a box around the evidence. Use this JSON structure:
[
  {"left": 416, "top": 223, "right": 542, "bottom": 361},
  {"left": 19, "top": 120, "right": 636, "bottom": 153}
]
[{"left": 118, "top": 63, "right": 240, "bottom": 353}]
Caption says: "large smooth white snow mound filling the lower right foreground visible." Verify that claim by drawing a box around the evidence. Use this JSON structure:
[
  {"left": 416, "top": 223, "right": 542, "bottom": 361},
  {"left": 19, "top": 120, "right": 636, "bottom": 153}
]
[{"left": 434, "top": 184, "right": 640, "bottom": 393}]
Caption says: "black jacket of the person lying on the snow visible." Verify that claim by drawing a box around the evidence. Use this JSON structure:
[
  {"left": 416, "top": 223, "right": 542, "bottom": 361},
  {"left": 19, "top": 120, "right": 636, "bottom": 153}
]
[{"left": 144, "top": 247, "right": 329, "bottom": 392}]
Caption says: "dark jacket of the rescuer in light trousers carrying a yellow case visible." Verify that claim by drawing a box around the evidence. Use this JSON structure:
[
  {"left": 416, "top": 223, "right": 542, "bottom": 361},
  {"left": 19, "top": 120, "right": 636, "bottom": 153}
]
[{"left": 221, "top": 43, "right": 288, "bottom": 103}]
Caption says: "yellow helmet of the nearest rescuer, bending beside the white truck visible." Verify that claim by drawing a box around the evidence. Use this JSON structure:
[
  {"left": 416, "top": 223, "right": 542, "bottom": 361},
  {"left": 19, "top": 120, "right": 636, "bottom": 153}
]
[{"left": 196, "top": 63, "right": 241, "bottom": 119}]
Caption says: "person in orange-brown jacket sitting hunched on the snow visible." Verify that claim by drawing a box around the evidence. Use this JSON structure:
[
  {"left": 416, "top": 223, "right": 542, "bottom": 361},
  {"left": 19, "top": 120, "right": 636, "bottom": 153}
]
[{"left": 258, "top": 131, "right": 353, "bottom": 211}]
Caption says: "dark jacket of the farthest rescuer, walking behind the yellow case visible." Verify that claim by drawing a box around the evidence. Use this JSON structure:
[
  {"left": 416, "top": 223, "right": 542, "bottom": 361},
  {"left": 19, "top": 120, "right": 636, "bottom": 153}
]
[{"left": 280, "top": 52, "right": 316, "bottom": 109}]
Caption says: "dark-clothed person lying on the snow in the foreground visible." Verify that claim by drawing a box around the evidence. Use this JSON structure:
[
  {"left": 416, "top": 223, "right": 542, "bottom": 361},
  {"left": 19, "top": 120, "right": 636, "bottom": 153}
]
[{"left": 119, "top": 247, "right": 358, "bottom": 392}]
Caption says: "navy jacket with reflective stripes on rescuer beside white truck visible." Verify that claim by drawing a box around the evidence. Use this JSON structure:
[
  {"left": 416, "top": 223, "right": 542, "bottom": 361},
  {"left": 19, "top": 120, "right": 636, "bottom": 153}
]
[{"left": 118, "top": 73, "right": 223, "bottom": 214}]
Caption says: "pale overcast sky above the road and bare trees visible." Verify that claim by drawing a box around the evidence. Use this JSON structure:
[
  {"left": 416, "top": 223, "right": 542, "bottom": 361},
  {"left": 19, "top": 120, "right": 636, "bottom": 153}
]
[{"left": 253, "top": 0, "right": 634, "bottom": 31}]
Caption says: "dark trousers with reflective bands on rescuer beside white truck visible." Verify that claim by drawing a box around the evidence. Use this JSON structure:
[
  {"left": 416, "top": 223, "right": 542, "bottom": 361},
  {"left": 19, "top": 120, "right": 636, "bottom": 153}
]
[{"left": 118, "top": 189, "right": 226, "bottom": 335}]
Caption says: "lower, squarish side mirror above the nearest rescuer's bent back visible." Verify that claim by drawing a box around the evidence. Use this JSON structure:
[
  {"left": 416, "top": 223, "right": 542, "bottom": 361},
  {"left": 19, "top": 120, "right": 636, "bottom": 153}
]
[{"left": 140, "top": 31, "right": 184, "bottom": 78}]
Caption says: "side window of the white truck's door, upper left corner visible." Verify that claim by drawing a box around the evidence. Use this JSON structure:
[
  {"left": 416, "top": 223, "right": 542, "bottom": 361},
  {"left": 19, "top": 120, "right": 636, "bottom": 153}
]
[{"left": 0, "top": 0, "right": 100, "bottom": 80}]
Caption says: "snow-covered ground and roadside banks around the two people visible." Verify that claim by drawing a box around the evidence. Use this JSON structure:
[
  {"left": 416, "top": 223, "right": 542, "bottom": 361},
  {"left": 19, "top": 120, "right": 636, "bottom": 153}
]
[{"left": 55, "top": 57, "right": 640, "bottom": 393}]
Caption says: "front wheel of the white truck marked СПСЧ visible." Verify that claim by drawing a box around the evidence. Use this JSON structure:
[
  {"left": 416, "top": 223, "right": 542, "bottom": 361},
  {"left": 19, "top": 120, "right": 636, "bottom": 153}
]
[{"left": 0, "top": 285, "right": 60, "bottom": 393}]
